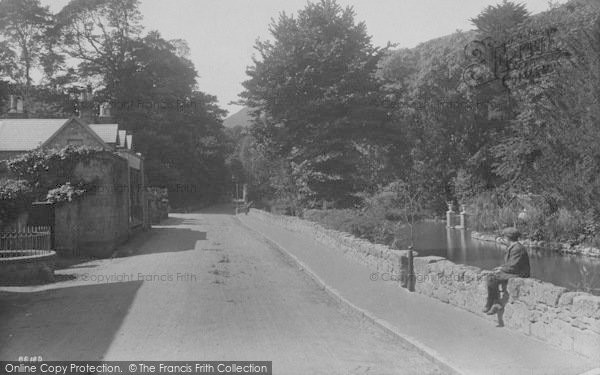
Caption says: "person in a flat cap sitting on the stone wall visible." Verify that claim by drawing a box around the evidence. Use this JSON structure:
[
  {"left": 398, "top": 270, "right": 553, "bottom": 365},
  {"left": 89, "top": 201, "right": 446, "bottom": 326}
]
[{"left": 483, "top": 228, "right": 530, "bottom": 315}]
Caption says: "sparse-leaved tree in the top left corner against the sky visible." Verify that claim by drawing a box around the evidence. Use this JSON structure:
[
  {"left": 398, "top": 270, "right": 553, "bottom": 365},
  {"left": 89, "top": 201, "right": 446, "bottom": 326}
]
[{"left": 0, "top": 0, "right": 57, "bottom": 96}]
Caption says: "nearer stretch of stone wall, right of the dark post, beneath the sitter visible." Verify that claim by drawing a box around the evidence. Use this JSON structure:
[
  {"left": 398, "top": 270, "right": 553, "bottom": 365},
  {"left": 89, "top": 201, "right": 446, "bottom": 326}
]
[{"left": 414, "top": 257, "right": 600, "bottom": 360}]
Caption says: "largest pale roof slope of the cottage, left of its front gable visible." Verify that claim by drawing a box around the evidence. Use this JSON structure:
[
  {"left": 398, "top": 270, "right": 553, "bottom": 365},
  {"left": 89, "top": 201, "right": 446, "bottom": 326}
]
[{"left": 0, "top": 119, "right": 69, "bottom": 151}]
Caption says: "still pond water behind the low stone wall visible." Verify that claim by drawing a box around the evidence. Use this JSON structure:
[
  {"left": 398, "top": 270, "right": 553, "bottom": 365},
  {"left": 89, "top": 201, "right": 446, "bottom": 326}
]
[{"left": 396, "top": 222, "right": 600, "bottom": 295}]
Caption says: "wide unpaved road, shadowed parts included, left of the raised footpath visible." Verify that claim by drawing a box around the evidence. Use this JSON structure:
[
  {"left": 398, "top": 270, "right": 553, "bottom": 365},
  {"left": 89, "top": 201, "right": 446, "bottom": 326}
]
[{"left": 0, "top": 208, "right": 441, "bottom": 375}]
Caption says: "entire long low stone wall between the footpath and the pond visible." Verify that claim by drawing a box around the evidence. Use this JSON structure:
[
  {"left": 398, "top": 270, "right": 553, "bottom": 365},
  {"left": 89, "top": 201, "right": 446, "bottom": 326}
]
[{"left": 249, "top": 209, "right": 600, "bottom": 360}]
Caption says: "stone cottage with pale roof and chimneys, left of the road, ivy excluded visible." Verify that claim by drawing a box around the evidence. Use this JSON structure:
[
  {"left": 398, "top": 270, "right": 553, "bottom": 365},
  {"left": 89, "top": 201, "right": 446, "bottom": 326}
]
[{"left": 0, "top": 117, "right": 148, "bottom": 257}]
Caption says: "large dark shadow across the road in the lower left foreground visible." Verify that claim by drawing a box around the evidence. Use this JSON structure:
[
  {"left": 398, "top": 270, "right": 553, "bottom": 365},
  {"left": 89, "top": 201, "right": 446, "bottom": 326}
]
[{"left": 0, "top": 281, "right": 142, "bottom": 361}]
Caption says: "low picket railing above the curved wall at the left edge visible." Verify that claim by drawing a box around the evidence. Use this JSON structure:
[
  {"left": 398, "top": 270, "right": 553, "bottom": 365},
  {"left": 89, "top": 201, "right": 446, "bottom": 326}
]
[{"left": 0, "top": 226, "right": 51, "bottom": 253}]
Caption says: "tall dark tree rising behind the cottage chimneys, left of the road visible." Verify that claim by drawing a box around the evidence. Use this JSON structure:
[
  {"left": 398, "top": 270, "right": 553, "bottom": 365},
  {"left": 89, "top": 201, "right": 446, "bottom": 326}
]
[{"left": 57, "top": 0, "right": 228, "bottom": 206}]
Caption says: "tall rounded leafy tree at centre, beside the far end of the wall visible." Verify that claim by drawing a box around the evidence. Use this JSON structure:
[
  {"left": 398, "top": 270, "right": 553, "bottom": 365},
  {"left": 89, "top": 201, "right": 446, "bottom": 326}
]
[{"left": 241, "top": 0, "right": 393, "bottom": 205}]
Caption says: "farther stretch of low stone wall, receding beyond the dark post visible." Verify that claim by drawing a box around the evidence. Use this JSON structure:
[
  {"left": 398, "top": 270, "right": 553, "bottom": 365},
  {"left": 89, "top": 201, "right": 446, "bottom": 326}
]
[{"left": 249, "top": 209, "right": 416, "bottom": 283}]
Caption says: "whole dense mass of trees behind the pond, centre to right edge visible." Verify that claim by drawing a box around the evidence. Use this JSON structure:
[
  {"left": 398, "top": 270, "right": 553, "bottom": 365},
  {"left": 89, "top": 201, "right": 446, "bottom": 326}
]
[{"left": 235, "top": 0, "right": 600, "bottom": 223}]
